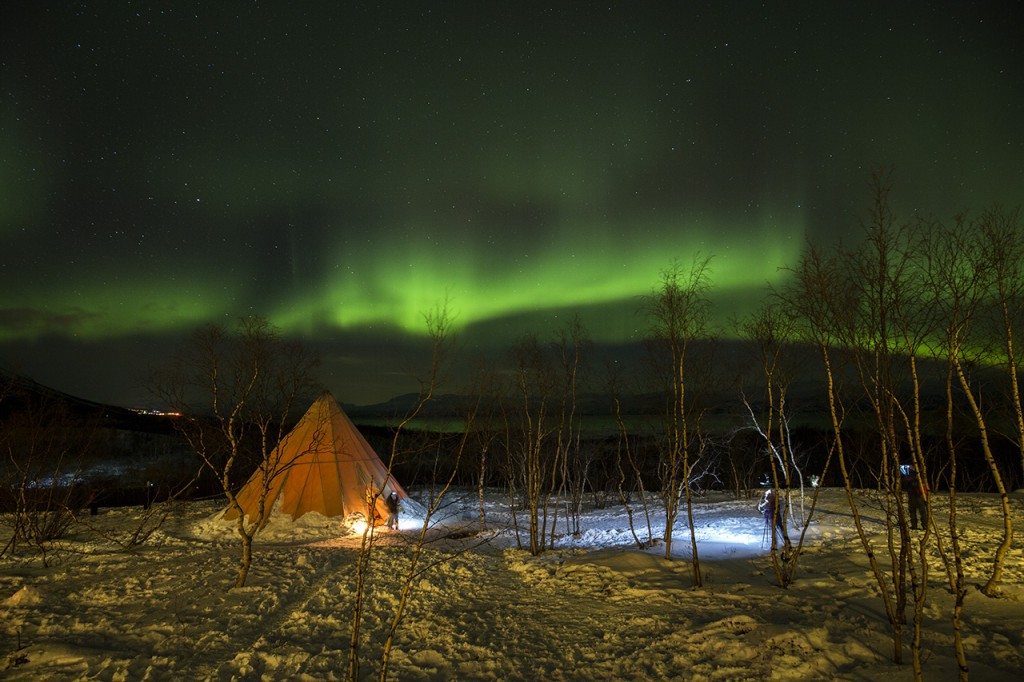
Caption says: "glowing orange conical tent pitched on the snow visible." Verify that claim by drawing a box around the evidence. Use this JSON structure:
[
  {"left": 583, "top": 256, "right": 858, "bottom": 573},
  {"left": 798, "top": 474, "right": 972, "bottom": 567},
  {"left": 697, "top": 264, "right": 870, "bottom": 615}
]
[{"left": 224, "top": 391, "right": 408, "bottom": 527}]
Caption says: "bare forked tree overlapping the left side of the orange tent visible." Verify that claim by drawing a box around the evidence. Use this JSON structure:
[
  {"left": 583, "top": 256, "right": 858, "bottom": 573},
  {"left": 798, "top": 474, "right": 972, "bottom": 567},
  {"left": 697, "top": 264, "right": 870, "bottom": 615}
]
[{"left": 153, "top": 316, "right": 318, "bottom": 588}]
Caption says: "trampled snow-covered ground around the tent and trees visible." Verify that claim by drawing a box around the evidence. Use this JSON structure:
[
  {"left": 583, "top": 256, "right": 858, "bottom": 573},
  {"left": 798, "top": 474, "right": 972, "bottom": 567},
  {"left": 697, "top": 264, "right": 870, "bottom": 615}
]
[{"left": 0, "top": 489, "right": 1024, "bottom": 681}]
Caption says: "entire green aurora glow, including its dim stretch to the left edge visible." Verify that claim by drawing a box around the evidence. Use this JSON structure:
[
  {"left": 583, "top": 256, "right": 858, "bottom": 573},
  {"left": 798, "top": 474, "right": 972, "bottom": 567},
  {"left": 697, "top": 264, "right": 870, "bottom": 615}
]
[{"left": 0, "top": 208, "right": 804, "bottom": 342}]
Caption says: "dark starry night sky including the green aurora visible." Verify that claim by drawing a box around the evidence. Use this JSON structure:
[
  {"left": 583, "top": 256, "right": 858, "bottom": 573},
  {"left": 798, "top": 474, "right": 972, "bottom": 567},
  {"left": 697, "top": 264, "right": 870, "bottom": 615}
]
[{"left": 0, "top": 0, "right": 1024, "bottom": 406}]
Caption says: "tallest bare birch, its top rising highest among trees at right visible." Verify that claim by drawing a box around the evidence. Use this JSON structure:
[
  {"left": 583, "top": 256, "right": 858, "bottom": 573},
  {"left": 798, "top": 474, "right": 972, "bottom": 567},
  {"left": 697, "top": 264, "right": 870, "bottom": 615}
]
[{"left": 799, "top": 170, "right": 950, "bottom": 676}]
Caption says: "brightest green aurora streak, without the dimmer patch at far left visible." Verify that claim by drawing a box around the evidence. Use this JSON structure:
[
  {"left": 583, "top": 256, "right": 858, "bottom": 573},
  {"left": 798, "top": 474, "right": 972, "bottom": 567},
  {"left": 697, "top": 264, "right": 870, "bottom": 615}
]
[{"left": 290, "top": 212, "right": 803, "bottom": 342}]
